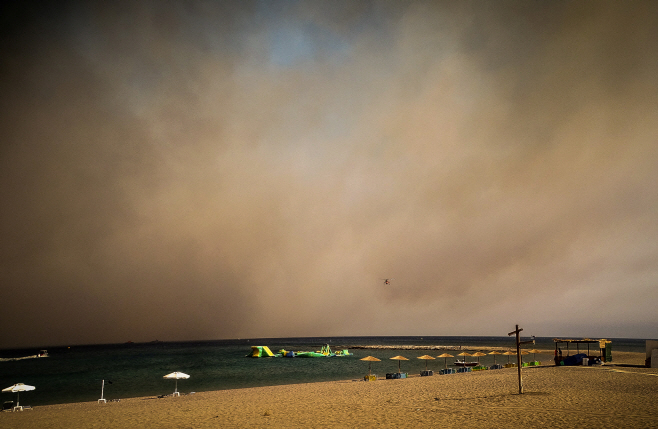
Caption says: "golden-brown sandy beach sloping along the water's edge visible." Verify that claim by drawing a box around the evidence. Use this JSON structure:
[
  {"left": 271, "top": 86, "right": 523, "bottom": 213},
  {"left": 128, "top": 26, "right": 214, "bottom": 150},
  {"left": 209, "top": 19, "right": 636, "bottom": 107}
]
[{"left": 0, "top": 352, "right": 658, "bottom": 429}]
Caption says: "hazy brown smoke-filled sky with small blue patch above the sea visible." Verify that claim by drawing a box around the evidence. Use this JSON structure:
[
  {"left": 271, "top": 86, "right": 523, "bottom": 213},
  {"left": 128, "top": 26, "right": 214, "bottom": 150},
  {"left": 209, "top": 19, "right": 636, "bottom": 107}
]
[{"left": 0, "top": 0, "right": 658, "bottom": 348}]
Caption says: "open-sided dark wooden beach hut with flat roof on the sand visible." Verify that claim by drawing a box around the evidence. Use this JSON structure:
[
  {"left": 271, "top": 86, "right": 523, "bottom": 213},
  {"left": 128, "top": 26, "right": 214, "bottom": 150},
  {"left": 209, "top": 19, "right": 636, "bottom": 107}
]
[{"left": 553, "top": 338, "right": 612, "bottom": 366}]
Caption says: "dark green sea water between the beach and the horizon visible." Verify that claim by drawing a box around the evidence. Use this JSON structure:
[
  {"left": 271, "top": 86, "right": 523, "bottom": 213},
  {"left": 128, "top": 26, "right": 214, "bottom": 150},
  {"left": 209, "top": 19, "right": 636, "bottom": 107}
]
[{"left": 0, "top": 337, "right": 645, "bottom": 406}]
